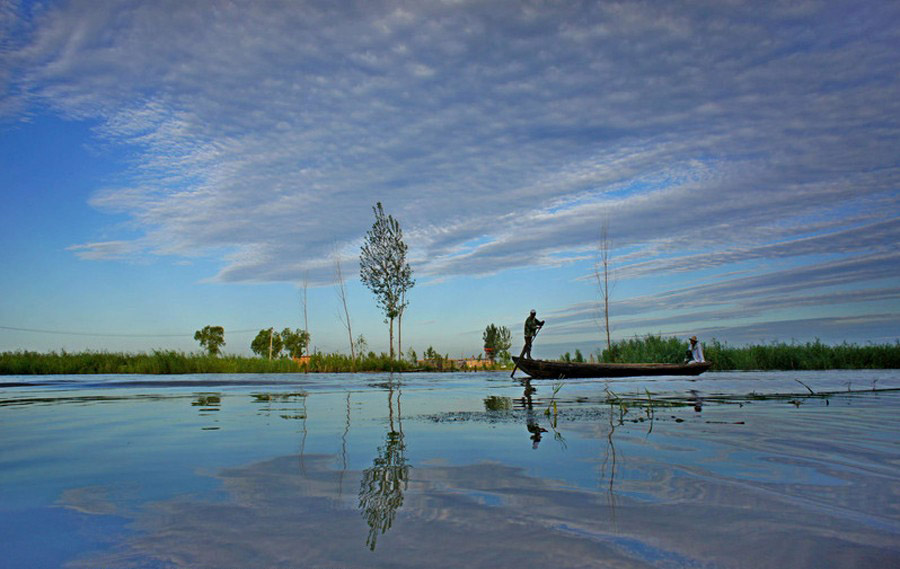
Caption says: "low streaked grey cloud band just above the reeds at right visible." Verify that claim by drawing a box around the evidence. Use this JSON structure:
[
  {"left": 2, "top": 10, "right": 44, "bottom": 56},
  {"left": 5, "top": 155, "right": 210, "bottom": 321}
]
[{"left": 547, "top": 251, "right": 900, "bottom": 341}]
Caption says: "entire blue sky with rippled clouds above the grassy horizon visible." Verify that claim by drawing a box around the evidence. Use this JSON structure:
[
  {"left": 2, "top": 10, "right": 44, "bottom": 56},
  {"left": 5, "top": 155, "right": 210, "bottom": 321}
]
[{"left": 0, "top": 0, "right": 900, "bottom": 357}]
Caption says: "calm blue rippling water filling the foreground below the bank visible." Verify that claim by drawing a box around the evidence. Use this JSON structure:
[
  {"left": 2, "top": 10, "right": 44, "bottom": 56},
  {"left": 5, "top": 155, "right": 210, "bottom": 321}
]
[{"left": 0, "top": 371, "right": 900, "bottom": 569}]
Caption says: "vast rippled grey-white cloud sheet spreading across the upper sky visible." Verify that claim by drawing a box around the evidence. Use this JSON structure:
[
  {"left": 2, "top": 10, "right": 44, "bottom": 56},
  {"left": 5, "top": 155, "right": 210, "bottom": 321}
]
[{"left": 0, "top": 0, "right": 900, "bottom": 342}]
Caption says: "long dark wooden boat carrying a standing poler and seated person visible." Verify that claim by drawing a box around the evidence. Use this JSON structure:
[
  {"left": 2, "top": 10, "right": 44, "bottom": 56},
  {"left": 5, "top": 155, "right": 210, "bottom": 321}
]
[{"left": 513, "top": 356, "right": 712, "bottom": 379}]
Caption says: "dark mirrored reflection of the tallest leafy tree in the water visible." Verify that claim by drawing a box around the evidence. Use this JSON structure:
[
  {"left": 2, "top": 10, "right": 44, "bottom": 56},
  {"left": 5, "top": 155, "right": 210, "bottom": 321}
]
[{"left": 359, "top": 381, "right": 410, "bottom": 551}]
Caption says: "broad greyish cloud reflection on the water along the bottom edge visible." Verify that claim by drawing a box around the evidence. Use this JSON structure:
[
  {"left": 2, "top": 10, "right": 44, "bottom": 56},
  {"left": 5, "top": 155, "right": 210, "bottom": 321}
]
[{"left": 65, "top": 442, "right": 897, "bottom": 569}]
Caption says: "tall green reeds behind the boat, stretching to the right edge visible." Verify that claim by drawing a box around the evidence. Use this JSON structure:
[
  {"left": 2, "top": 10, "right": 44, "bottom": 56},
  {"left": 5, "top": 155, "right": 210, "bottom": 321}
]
[{"left": 599, "top": 335, "right": 900, "bottom": 371}]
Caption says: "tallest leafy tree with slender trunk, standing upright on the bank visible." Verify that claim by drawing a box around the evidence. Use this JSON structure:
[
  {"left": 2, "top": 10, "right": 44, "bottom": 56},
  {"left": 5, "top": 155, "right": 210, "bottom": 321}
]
[{"left": 359, "top": 202, "right": 416, "bottom": 359}]
